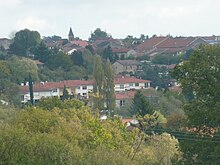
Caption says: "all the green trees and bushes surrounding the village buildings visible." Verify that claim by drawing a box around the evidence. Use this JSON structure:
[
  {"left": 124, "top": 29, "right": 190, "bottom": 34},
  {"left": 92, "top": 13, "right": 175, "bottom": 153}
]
[{"left": 0, "top": 29, "right": 220, "bottom": 162}]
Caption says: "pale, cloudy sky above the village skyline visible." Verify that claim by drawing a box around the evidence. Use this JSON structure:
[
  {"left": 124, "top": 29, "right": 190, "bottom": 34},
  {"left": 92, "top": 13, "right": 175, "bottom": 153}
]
[{"left": 0, "top": 0, "right": 220, "bottom": 40}]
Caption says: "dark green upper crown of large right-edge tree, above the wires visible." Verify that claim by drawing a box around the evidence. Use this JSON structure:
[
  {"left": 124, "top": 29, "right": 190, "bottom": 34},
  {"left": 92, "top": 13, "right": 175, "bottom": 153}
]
[{"left": 173, "top": 46, "right": 220, "bottom": 127}]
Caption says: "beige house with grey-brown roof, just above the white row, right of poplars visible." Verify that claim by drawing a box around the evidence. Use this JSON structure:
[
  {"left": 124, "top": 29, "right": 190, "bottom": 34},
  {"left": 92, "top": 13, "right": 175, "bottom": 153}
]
[{"left": 112, "top": 60, "right": 142, "bottom": 74}]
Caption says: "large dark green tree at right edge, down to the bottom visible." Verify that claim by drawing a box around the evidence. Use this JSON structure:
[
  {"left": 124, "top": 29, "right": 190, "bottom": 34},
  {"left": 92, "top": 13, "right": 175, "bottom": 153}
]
[{"left": 172, "top": 46, "right": 220, "bottom": 164}]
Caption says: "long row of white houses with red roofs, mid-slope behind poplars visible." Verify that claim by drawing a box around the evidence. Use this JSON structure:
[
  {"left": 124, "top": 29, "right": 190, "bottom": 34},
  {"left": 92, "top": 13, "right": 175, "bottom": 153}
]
[{"left": 20, "top": 77, "right": 150, "bottom": 107}]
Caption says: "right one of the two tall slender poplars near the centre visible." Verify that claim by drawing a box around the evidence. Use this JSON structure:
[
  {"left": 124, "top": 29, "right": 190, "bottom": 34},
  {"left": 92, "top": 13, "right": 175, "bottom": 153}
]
[{"left": 104, "top": 60, "right": 115, "bottom": 111}]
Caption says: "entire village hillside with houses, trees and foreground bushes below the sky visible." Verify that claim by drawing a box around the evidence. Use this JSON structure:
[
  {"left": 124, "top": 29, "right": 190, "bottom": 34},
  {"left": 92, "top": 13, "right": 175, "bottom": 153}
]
[{"left": 0, "top": 27, "right": 220, "bottom": 165}]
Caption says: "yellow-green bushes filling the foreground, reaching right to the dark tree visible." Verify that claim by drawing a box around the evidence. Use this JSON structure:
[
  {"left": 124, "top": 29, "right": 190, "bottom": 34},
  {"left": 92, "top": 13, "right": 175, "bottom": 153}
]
[{"left": 0, "top": 98, "right": 180, "bottom": 165}]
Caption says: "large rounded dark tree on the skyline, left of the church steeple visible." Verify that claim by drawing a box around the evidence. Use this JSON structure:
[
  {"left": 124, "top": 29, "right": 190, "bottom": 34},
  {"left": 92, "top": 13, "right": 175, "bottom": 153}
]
[{"left": 10, "top": 29, "right": 41, "bottom": 57}]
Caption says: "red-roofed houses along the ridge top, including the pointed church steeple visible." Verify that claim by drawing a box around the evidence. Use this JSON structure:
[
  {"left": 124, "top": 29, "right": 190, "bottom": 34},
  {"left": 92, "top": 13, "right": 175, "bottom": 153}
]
[{"left": 40, "top": 28, "right": 220, "bottom": 59}]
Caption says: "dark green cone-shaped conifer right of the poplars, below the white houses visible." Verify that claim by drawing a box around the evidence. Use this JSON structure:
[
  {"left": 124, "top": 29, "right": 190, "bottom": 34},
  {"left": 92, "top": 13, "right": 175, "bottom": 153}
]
[{"left": 130, "top": 90, "right": 154, "bottom": 117}]
